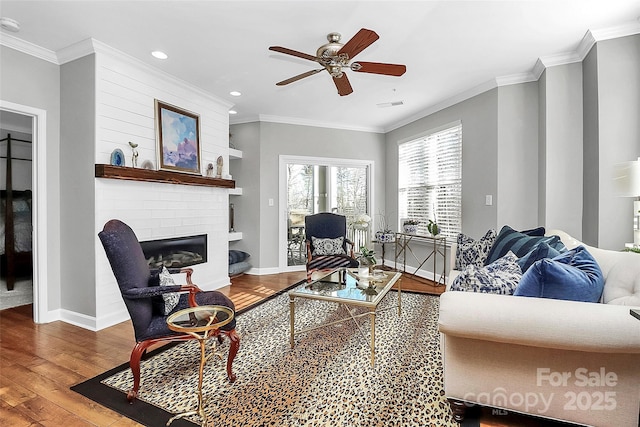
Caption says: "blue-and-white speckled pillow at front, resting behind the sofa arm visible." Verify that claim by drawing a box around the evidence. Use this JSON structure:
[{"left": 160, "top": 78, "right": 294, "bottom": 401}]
[{"left": 451, "top": 252, "right": 522, "bottom": 295}]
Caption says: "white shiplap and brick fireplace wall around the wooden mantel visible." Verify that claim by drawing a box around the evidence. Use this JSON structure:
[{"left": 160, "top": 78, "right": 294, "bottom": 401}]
[{"left": 89, "top": 40, "right": 231, "bottom": 330}]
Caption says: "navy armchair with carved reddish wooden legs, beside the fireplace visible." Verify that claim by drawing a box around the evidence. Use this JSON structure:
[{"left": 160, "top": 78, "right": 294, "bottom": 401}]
[{"left": 98, "top": 220, "right": 240, "bottom": 402}]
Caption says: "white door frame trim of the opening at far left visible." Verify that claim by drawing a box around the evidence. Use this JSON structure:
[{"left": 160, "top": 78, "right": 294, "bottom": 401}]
[{"left": 0, "top": 100, "right": 47, "bottom": 323}]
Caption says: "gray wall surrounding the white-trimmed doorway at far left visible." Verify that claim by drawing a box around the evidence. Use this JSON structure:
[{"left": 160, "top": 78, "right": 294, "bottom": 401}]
[{"left": 0, "top": 46, "right": 61, "bottom": 311}]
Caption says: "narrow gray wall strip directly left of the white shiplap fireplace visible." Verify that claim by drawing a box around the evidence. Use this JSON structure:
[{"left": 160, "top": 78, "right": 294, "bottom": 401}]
[{"left": 60, "top": 55, "right": 97, "bottom": 316}]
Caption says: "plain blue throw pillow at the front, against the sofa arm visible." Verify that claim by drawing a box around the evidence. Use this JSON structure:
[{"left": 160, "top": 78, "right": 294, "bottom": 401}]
[{"left": 513, "top": 246, "right": 604, "bottom": 302}]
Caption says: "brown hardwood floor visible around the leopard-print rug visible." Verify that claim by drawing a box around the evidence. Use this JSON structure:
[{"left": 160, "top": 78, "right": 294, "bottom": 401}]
[{"left": 0, "top": 272, "right": 533, "bottom": 427}]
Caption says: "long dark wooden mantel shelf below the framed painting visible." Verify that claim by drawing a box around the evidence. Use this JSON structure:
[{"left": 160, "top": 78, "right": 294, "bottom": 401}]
[{"left": 96, "top": 164, "right": 236, "bottom": 188}]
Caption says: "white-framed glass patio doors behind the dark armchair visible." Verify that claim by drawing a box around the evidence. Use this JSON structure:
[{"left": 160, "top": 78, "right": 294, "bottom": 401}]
[{"left": 279, "top": 156, "right": 373, "bottom": 271}]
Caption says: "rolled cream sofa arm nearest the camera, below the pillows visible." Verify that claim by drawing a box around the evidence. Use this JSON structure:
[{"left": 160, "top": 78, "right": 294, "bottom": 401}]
[{"left": 438, "top": 291, "right": 640, "bottom": 354}]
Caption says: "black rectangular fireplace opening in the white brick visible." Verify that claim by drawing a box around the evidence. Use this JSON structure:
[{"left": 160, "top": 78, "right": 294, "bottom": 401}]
[{"left": 140, "top": 234, "right": 207, "bottom": 268}]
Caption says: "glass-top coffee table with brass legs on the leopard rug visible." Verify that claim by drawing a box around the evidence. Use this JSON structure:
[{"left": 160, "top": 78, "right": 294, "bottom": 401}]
[{"left": 289, "top": 268, "right": 402, "bottom": 366}]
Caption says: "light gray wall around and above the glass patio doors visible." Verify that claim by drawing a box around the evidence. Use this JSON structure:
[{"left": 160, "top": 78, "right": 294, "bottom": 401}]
[{"left": 231, "top": 122, "right": 386, "bottom": 269}]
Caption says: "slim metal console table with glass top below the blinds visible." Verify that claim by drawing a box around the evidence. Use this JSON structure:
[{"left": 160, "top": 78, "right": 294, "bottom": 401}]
[{"left": 394, "top": 233, "right": 447, "bottom": 286}]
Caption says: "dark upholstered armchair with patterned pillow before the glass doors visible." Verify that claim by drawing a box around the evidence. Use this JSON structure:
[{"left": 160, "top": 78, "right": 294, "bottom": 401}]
[{"left": 305, "top": 212, "right": 358, "bottom": 281}]
